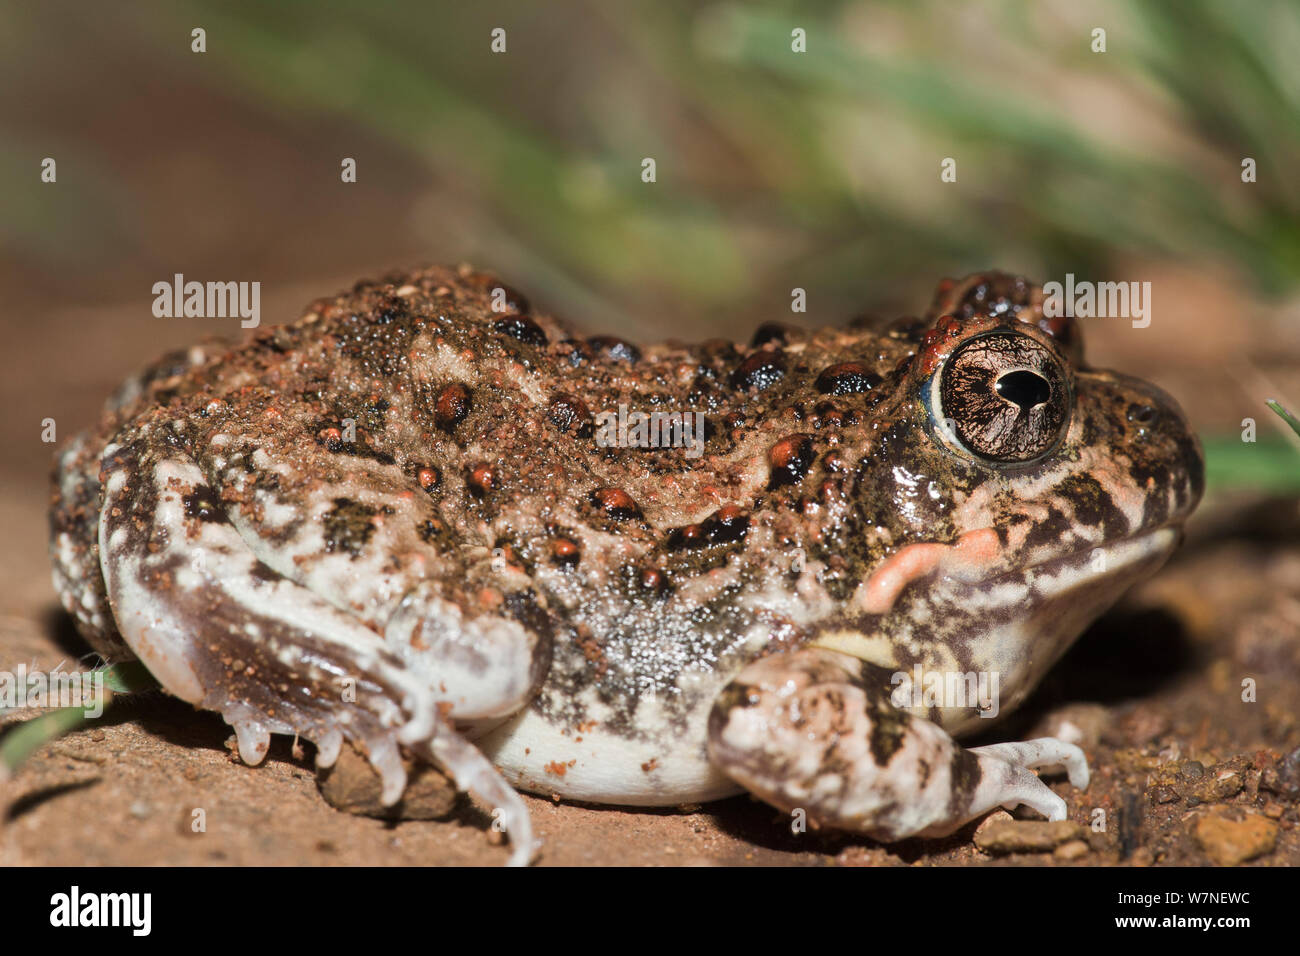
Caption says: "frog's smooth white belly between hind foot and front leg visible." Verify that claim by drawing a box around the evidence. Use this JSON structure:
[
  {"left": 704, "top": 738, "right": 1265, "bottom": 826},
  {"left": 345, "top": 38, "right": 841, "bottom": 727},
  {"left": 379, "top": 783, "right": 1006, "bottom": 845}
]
[{"left": 476, "top": 705, "right": 741, "bottom": 806}]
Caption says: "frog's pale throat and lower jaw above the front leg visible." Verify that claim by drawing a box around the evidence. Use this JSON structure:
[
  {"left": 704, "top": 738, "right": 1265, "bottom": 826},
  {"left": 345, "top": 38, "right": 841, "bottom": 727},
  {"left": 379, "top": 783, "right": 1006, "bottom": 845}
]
[{"left": 813, "top": 528, "right": 1179, "bottom": 734}]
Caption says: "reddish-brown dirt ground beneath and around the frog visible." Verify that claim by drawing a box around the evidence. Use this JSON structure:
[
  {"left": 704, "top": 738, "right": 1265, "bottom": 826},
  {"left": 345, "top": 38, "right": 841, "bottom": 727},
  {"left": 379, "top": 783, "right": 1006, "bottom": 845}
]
[{"left": 0, "top": 290, "right": 1300, "bottom": 865}]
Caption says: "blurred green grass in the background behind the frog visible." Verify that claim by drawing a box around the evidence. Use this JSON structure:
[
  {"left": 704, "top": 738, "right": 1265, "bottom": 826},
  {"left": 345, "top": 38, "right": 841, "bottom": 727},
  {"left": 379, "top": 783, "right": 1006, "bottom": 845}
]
[{"left": 0, "top": 0, "right": 1300, "bottom": 488}]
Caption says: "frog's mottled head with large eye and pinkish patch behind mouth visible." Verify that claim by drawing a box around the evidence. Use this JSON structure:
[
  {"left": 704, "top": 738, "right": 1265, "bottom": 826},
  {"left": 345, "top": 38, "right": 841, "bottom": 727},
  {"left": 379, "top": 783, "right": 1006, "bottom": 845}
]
[{"left": 837, "top": 276, "right": 1204, "bottom": 723}]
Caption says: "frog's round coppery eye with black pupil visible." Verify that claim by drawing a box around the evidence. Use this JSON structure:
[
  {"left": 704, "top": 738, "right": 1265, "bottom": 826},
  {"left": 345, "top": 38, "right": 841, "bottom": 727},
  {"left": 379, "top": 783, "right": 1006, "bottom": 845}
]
[{"left": 939, "top": 332, "right": 1073, "bottom": 463}]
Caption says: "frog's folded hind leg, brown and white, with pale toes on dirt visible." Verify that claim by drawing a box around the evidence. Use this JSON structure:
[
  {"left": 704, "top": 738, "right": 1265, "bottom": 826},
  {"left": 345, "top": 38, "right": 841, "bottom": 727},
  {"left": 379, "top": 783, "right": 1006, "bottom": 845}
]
[{"left": 99, "top": 427, "right": 545, "bottom": 864}]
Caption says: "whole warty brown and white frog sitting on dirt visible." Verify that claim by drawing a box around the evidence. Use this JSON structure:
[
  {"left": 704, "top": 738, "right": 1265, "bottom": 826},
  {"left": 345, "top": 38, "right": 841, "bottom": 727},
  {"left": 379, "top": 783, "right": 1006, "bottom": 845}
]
[{"left": 49, "top": 265, "right": 1204, "bottom": 864}]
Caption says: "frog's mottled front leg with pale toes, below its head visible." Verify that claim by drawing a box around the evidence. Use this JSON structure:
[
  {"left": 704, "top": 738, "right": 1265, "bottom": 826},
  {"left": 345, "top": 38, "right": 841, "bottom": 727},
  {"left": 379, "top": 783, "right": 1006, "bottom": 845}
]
[{"left": 709, "top": 648, "right": 1088, "bottom": 840}]
